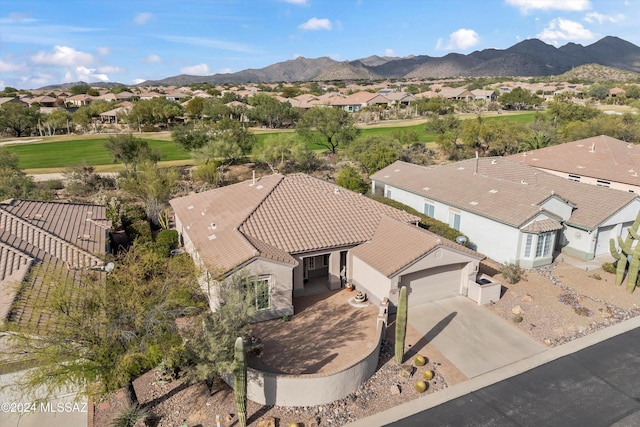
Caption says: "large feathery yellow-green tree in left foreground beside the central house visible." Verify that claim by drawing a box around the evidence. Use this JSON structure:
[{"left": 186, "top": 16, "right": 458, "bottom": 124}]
[{"left": 5, "top": 245, "right": 208, "bottom": 405}]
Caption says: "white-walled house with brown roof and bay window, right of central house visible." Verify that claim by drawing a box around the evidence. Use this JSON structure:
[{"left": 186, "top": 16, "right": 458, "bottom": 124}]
[{"left": 371, "top": 157, "right": 640, "bottom": 268}]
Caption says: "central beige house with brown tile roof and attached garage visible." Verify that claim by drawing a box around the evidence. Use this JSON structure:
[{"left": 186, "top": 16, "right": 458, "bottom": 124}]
[{"left": 170, "top": 174, "right": 482, "bottom": 320}]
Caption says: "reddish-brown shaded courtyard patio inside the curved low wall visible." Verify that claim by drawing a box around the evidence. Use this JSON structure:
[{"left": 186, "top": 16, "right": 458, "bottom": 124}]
[{"left": 249, "top": 290, "right": 378, "bottom": 375}]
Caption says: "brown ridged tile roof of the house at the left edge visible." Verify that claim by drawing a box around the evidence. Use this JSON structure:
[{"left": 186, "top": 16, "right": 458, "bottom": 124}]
[{"left": 0, "top": 199, "right": 111, "bottom": 331}]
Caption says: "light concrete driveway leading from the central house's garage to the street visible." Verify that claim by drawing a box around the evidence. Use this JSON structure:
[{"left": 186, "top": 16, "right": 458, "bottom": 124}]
[{"left": 408, "top": 296, "right": 547, "bottom": 378}]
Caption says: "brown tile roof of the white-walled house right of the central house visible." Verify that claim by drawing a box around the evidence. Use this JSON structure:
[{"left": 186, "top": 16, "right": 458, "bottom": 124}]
[{"left": 372, "top": 157, "right": 636, "bottom": 230}]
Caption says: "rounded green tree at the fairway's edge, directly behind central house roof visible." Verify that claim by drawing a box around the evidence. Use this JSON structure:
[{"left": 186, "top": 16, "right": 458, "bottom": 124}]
[{"left": 296, "top": 107, "right": 360, "bottom": 154}]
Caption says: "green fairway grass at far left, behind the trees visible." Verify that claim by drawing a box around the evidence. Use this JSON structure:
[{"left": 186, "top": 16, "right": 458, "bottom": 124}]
[{"left": 7, "top": 137, "right": 190, "bottom": 169}]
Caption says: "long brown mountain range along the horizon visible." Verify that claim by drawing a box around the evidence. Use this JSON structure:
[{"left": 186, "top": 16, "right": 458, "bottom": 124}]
[{"left": 40, "top": 36, "right": 640, "bottom": 87}]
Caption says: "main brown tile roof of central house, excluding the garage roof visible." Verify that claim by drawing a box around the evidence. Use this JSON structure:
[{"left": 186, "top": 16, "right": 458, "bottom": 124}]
[{"left": 170, "top": 174, "right": 418, "bottom": 272}]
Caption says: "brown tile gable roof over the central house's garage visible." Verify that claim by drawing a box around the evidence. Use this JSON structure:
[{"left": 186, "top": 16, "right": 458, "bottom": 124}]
[{"left": 351, "top": 218, "right": 483, "bottom": 277}]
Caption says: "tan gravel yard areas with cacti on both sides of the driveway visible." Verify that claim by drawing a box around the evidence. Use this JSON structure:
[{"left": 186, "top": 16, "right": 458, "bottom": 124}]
[{"left": 94, "top": 257, "right": 640, "bottom": 427}]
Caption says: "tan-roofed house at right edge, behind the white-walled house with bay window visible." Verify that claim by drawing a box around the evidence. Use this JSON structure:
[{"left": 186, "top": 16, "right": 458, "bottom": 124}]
[{"left": 507, "top": 135, "right": 640, "bottom": 194}]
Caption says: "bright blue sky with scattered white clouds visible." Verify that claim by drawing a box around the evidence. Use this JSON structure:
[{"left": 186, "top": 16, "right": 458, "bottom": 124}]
[{"left": 0, "top": 0, "right": 640, "bottom": 89}]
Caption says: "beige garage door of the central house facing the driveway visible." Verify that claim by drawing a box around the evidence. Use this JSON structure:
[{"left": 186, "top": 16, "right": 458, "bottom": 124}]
[{"left": 401, "top": 264, "right": 463, "bottom": 306}]
